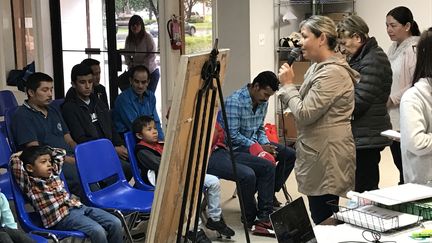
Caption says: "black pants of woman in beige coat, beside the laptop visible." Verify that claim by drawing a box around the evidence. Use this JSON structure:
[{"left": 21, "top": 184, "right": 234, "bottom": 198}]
[{"left": 308, "top": 194, "right": 339, "bottom": 225}]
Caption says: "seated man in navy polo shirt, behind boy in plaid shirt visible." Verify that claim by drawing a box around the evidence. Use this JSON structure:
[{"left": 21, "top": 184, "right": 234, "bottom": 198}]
[{"left": 11, "top": 72, "right": 81, "bottom": 196}]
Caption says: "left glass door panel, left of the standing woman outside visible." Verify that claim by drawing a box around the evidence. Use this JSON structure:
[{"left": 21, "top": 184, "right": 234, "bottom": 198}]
[{"left": 60, "top": 0, "right": 110, "bottom": 102}]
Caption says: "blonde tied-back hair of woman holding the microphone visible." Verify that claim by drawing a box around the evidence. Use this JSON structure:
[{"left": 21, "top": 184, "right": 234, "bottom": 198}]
[{"left": 300, "top": 15, "right": 337, "bottom": 50}]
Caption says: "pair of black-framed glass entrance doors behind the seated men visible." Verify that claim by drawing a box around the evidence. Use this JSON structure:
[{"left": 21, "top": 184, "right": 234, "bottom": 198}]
[{"left": 50, "top": 0, "right": 161, "bottom": 106}]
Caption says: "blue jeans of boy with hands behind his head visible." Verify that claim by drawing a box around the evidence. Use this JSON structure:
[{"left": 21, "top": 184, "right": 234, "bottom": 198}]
[{"left": 52, "top": 205, "right": 123, "bottom": 243}]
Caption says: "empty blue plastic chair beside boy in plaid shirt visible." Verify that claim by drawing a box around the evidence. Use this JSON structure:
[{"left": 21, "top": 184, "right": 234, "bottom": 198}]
[{"left": 75, "top": 138, "right": 154, "bottom": 241}]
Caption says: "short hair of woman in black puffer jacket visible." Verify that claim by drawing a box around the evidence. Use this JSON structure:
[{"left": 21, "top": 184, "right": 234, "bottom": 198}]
[{"left": 336, "top": 15, "right": 369, "bottom": 43}]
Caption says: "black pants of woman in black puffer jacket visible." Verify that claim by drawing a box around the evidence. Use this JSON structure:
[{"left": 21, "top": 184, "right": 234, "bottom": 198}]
[{"left": 355, "top": 148, "right": 383, "bottom": 192}]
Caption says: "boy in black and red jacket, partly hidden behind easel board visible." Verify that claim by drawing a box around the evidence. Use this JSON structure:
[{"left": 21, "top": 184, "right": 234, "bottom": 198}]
[{"left": 132, "top": 116, "right": 235, "bottom": 242}]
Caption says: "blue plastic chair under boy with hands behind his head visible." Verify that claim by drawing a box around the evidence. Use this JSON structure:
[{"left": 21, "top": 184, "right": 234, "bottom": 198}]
[{"left": 10, "top": 174, "right": 87, "bottom": 242}]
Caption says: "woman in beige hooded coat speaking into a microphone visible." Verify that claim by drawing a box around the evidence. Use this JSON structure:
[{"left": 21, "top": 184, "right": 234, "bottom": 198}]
[{"left": 279, "top": 16, "right": 359, "bottom": 224}]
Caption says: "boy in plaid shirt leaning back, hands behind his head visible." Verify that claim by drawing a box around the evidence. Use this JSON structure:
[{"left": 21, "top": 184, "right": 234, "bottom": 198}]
[{"left": 11, "top": 146, "right": 123, "bottom": 243}]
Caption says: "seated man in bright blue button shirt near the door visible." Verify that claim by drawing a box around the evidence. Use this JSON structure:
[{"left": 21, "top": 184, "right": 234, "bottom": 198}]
[{"left": 113, "top": 66, "right": 164, "bottom": 141}]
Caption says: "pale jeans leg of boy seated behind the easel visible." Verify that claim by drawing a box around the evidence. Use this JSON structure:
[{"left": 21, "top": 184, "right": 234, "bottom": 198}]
[{"left": 204, "top": 174, "right": 222, "bottom": 221}]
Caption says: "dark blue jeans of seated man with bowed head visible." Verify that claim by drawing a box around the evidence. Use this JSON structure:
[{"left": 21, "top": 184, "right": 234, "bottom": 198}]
[{"left": 207, "top": 149, "right": 275, "bottom": 224}]
